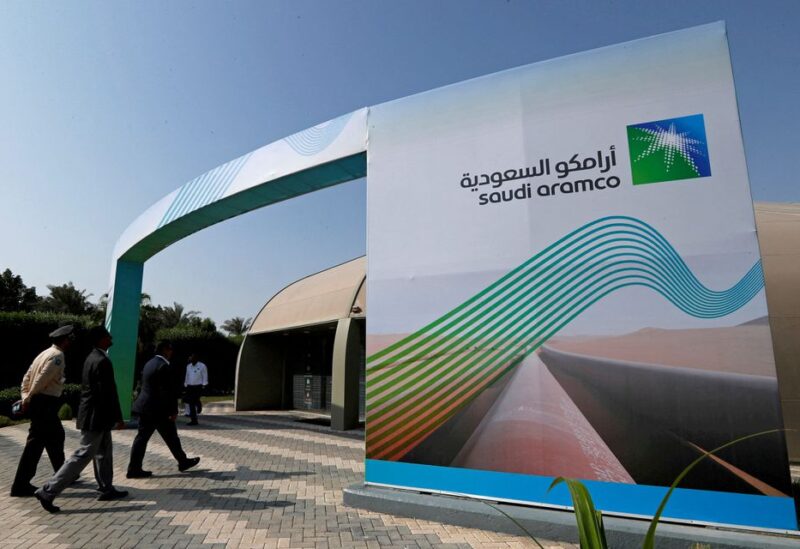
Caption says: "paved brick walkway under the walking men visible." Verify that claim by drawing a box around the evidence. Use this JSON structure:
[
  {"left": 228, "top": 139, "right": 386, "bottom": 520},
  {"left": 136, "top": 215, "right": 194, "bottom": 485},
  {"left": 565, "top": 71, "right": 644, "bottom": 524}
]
[{"left": 0, "top": 405, "right": 576, "bottom": 548}]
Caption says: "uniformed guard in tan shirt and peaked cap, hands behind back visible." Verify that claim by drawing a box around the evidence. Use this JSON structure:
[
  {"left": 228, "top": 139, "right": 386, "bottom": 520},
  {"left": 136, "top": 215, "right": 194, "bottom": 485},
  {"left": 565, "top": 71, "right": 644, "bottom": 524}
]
[{"left": 11, "top": 325, "right": 75, "bottom": 497}]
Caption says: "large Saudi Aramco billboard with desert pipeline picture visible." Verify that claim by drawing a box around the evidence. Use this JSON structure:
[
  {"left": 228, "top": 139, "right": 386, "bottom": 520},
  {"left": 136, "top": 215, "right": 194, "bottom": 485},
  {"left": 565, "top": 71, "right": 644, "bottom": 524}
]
[{"left": 366, "top": 23, "right": 797, "bottom": 529}]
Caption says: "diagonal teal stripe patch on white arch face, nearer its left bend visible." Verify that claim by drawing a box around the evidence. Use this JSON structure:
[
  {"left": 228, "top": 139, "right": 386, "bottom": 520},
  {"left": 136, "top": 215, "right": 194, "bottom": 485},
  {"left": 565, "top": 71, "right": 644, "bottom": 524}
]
[{"left": 158, "top": 153, "right": 252, "bottom": 228}]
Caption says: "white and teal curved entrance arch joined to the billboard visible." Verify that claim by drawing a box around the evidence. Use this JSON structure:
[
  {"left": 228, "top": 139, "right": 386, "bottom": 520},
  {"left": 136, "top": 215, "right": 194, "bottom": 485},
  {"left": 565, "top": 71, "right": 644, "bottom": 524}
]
[{"left": 106, "top": 108, "right": 368, "bottom": 416}]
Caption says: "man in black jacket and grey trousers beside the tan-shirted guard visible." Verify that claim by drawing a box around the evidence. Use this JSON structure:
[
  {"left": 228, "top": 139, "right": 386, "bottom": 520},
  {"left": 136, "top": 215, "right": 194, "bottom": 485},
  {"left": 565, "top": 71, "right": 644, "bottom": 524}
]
[{"left": 34, "top": 326, "right": 128, "bottom": 513}]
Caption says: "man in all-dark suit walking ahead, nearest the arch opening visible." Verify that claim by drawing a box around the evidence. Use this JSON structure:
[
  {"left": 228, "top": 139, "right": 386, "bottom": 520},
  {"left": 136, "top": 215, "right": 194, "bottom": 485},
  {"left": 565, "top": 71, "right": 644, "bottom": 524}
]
[{"left": 128, "top": 341, "right": 200, "bottom": 478}]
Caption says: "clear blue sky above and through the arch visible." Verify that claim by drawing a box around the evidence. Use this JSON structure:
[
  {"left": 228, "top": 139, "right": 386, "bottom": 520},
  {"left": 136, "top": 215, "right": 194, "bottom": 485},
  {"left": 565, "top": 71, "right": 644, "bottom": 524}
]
[{"left": 0, "top": 0, "right": 800, "bottom": 323}]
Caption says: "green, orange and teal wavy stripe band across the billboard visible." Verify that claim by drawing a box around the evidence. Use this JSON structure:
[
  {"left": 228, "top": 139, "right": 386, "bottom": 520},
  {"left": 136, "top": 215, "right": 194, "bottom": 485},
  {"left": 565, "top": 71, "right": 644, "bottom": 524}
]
[{"left": 367, "top": 216, "right": 764, "bottom": 460}]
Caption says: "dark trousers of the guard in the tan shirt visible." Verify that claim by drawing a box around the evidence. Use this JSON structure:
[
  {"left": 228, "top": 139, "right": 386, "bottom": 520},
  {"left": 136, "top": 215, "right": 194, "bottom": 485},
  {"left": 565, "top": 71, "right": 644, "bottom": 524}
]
[{"left": 13, "top": 395, "right": 64, "bottom": 489}]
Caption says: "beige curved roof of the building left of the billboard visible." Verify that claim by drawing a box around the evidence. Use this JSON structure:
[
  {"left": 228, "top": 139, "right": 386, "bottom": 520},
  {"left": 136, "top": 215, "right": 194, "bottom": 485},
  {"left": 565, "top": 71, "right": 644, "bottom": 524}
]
[{"left": 249, "top": 257, "right": 367, "bottom": 334}]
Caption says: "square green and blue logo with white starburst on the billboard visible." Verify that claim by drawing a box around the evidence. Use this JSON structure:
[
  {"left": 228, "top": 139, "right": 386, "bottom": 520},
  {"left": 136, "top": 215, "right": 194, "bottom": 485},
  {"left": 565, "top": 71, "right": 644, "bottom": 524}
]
[{"left": 628, "top": 114, "right": 711, "bottom": 185}]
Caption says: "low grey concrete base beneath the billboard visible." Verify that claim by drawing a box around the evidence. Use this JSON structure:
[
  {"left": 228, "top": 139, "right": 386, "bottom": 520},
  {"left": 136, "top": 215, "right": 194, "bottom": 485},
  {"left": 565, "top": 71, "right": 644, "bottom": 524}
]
[{"left": 344, "top": 484, "right": 800, "bottom": 549}]
